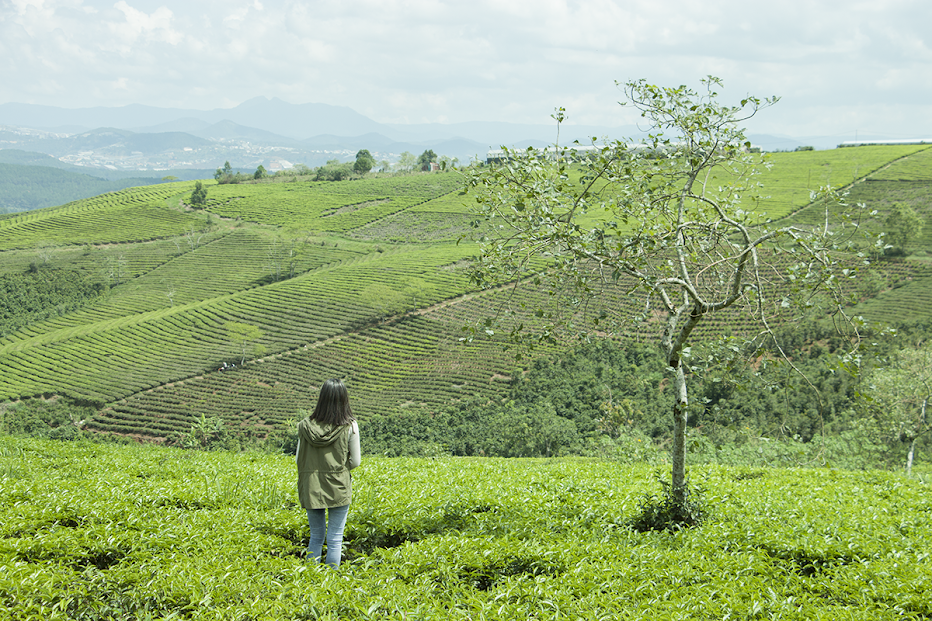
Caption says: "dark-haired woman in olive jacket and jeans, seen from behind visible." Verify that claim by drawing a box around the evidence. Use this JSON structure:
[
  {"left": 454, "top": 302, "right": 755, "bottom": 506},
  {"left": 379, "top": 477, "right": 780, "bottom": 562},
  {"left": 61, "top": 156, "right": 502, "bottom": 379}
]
[{"left": 297, "top": 379, "right": 361, "bottom": 568}]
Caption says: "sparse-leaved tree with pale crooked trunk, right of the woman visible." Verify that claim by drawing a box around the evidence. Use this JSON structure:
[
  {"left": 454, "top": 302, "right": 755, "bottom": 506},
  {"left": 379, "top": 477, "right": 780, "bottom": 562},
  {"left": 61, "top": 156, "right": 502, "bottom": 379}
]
[{"left": 467, "top": 76, "right": 863, "bottom": 507}]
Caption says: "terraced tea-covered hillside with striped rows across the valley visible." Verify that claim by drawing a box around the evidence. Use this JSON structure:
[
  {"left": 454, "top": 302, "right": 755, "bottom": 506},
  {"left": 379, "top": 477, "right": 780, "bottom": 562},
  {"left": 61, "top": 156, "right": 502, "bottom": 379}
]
[{"left": 0, "top": 147, "right": 932, "bottom": 440}]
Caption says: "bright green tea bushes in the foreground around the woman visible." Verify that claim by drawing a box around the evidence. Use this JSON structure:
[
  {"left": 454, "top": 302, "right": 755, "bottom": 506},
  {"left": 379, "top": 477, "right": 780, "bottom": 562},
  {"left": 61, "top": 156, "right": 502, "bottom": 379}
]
[{"left": 0, "top": 436, "right": 932, "bottom": 621}]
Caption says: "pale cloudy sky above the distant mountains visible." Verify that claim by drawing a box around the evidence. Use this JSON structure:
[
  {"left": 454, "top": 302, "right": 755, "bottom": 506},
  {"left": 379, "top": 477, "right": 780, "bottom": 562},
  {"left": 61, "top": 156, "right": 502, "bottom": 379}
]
[{"left": 0, "top": 0, "right": 932, "bottom": 140}]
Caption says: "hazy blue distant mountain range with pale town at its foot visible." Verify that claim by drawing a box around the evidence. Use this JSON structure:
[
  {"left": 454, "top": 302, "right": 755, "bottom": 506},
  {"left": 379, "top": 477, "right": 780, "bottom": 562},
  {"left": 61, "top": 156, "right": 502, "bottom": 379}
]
[{"left": 0, "top": 97, "right": 896, "bottom": 177}]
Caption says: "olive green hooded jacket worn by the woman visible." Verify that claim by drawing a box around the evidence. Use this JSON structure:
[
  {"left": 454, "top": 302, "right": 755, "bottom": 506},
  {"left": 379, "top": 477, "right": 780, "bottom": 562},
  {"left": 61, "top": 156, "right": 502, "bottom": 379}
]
[{"left": 297, "top": 418, "right": 358, "bottom": 509}]
